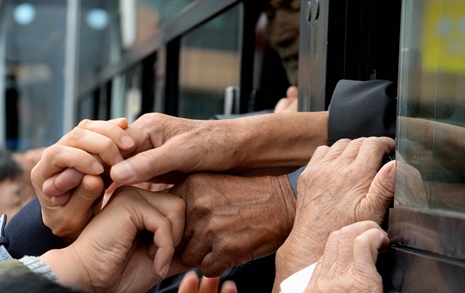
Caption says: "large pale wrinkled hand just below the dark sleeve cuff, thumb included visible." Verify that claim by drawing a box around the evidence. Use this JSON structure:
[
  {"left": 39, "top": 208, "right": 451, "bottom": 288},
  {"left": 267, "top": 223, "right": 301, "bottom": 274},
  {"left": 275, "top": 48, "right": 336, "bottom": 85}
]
[{"left": 274, "top": 137, "right": 395, "bottom": 292}]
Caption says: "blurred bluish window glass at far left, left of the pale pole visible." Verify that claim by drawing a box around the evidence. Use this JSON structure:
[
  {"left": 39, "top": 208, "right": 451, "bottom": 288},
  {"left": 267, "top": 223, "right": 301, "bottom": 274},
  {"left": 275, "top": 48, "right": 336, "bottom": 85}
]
[{"left": 0, "top": 0, "right": 67, "bottom": 151}]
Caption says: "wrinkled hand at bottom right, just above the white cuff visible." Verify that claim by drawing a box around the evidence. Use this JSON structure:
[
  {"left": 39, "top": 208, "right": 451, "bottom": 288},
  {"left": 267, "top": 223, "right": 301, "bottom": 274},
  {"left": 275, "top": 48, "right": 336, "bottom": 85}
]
[{"left": 305, "top": 221, "right": 389, "bottom": 293}]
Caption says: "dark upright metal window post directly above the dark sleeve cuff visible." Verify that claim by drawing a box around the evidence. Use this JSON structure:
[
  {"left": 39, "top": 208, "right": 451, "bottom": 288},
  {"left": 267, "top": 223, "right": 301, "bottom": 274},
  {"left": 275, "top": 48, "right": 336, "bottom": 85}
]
[{"left": 298, "top": 0, "right": 401, "bottom": 111}]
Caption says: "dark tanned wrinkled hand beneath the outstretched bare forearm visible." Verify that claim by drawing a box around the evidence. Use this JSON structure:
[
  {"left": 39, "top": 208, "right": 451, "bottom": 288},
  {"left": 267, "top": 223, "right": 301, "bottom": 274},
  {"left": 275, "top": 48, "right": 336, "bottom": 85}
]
[{"left": 170, "top": 173, "right": 295, "bottom": 277}]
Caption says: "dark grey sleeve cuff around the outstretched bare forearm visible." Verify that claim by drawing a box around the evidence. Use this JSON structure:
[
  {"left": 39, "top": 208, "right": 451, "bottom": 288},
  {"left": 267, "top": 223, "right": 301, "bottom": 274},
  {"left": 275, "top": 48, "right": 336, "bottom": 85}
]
[{"left": 328, "top": 80, "right": 397, "bottom": 146}]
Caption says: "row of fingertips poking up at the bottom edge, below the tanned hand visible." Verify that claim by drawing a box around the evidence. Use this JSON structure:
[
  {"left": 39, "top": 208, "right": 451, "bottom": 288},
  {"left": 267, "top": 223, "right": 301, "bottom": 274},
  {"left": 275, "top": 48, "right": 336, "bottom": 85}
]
[{"left": 178, "top": 271, "right": 237, "bottom": 293}]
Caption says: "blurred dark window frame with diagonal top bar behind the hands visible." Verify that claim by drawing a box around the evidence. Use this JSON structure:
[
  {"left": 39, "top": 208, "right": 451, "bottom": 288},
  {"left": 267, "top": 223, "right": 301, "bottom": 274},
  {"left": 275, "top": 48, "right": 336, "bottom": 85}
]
[{"left": 77, "top": 0, "right": 255, "bottom": 119}]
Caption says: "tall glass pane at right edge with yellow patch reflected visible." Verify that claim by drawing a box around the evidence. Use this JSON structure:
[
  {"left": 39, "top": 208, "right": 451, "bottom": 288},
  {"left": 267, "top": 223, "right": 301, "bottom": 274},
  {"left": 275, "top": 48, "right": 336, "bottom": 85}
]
[{"left": 396, "top": 0, "right": 465, "bottom": 211}]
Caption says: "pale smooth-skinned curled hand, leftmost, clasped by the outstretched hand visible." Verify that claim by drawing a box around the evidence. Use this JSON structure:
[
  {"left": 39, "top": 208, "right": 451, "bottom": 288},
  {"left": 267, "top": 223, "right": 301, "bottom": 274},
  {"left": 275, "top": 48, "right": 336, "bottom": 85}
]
[{"left": 31, "top": 119, "right": 133, "bottom": 242}]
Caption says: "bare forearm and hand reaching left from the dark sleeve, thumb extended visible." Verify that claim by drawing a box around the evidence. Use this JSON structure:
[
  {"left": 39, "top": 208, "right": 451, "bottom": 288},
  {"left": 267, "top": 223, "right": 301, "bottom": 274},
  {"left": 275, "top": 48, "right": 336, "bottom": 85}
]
[{"left": 107, "top": 112, "right": 328, "bottom": 184}]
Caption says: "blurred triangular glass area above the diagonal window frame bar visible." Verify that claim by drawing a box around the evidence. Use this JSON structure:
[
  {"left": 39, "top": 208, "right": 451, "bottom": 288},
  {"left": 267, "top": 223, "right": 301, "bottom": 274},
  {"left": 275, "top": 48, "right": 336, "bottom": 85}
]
[{"left": 80, "top": 0, "right": 193, "bottom": 68}]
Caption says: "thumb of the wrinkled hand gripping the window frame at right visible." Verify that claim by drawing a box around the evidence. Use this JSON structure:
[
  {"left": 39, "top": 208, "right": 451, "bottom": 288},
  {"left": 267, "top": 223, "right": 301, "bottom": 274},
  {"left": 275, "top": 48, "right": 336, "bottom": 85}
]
[{"left": 361, "top": 161, "right": 396, "bottom": 224}]
